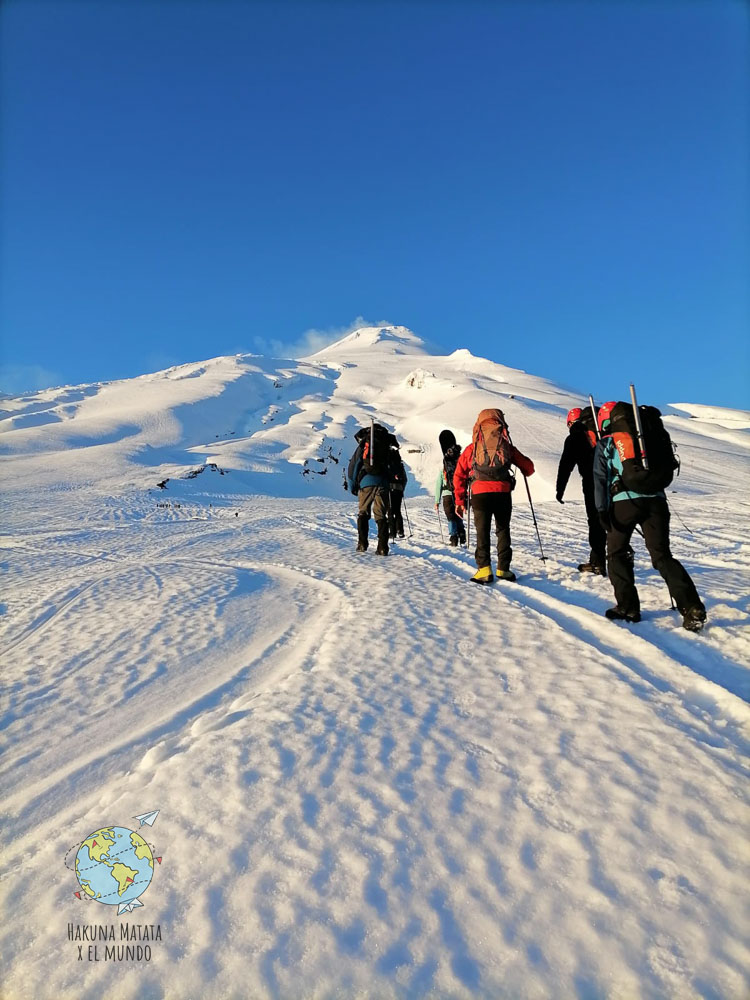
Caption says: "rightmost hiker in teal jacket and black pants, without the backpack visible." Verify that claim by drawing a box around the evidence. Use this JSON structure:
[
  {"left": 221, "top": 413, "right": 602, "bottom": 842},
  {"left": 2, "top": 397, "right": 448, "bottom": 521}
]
[{"left": 594, "top": 403, "right": 706, "bottom": 632}]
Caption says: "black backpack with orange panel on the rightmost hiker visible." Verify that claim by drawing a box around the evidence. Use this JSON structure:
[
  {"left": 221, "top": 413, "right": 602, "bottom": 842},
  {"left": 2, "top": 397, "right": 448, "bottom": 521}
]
[{"left": 609, "top": 402, "right": 680, "bottom": 493}]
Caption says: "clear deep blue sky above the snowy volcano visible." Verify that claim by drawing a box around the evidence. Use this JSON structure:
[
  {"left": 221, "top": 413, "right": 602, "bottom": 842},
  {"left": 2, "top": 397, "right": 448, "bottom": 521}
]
[{"left": 0, "top": 0, "right": 750, "bottom": 408}]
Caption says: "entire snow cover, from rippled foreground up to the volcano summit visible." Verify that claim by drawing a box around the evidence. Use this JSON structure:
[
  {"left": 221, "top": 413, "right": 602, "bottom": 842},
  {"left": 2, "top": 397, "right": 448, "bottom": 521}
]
[{"left": 0, "top": 327, "right": 750, "bottom": 1000}]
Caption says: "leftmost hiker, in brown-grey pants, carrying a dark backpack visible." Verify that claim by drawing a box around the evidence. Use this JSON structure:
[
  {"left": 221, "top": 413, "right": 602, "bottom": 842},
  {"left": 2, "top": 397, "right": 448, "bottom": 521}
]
[{"left": 347, "top": 424, "right": 391, "bottom": 556}]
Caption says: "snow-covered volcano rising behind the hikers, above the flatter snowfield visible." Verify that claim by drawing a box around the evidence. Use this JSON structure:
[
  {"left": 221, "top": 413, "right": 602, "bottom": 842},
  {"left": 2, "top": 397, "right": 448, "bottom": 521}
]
[{"left": 0, "top": 326, "right": 750, "bottom": 501}]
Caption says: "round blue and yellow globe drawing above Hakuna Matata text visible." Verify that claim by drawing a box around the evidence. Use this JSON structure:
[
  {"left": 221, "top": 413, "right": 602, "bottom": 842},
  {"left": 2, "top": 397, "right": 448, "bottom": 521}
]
[{"left": 76, "top": 826, "right": 154, "bottom": 906}]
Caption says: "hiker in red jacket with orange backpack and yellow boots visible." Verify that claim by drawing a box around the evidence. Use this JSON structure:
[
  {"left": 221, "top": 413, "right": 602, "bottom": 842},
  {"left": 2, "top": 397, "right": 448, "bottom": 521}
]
[{"left": 453, "top": 410, "right": 534, "bottom": 583}]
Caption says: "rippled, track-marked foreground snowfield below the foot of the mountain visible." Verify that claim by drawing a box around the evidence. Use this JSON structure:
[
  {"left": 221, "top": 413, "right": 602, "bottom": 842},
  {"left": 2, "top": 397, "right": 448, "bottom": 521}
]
[{"left": 0, "top": 495, "right": 750, "bottom": 998}]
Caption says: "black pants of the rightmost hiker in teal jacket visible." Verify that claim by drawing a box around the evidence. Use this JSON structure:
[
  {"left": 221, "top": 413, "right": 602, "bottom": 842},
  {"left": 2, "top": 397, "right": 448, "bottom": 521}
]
[{"left": 607, "top": 497, "right": 703, "bottom": 614}]
